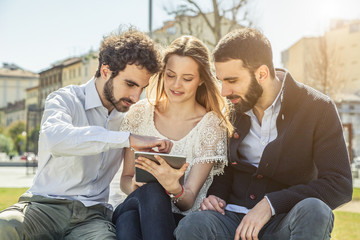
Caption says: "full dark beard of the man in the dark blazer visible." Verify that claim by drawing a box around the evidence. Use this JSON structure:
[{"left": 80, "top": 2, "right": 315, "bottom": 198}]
[{"left": 227, "top": 73, "right": 263, "bottom": 113}]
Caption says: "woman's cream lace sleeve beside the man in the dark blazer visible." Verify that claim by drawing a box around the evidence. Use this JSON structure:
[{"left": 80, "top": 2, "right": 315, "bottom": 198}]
[{"left": 192, "top": 112, "right": 228, "bottom": 175}]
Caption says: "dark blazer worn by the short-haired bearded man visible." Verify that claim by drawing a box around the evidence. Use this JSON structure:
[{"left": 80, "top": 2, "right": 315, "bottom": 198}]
[{"left": 208, "top": 69, "right": 352, "bottom": 214}]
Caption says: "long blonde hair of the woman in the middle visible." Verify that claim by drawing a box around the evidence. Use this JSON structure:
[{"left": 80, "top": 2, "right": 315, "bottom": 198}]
[{"left": 147, "top": 36, "right": 233, "bottom": 135}]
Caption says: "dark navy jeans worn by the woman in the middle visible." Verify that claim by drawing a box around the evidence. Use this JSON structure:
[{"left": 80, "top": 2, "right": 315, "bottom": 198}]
[{"left": 113, "top": 183, "right": 183, "bottom": 240}]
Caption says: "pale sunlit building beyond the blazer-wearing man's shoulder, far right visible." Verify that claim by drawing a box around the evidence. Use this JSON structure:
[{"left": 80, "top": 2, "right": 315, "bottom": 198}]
[{"left": 281, "top": 19, "right": 360, "bottom": 97}]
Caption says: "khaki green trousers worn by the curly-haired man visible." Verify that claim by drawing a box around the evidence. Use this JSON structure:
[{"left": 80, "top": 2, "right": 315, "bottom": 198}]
[{"left": 0, "top": 193, "right": 116, "bottom": 240}]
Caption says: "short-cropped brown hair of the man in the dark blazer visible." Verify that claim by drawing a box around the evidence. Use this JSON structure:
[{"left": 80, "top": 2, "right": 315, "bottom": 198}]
[{"left": 213, "top": 28, "right": 275, "bottom": 77}]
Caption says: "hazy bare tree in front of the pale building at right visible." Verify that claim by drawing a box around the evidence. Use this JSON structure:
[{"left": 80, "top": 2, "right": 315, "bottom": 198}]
[{"left": 305, "top": 36, "right": 346, "bottom": 99}]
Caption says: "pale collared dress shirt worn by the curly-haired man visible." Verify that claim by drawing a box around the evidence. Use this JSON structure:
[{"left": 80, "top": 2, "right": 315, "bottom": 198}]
[{"left": 28, "top": 78, "right": 129, "bottom": 208}]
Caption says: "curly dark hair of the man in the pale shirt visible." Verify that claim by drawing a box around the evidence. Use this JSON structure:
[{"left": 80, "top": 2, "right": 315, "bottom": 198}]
[{"left": 95, "top": 28, "right": 161, "bottom": 77}]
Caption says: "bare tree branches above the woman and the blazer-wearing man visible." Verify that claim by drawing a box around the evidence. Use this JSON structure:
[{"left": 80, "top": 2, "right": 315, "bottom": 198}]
[{"left": 164, "top": 0, "right": 252, "bottom": 47}]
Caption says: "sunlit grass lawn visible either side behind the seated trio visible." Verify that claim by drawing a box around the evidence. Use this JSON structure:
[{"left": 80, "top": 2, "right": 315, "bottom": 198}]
[{"left": 0, "top": 188, "right": 360, "bottom": 240}]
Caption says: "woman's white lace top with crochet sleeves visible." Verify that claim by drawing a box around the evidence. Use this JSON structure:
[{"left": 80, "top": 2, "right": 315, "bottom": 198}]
[{"left": 121, "top": 99, "right": 227, "bottom": 215}]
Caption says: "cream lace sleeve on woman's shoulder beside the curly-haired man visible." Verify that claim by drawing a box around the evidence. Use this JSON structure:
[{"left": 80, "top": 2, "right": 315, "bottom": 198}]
[{"left": 120, "top": 99, "right": 147, "bottom": 134}]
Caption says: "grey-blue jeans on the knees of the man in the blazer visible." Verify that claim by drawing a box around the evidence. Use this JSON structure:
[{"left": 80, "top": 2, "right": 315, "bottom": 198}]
[{"left": 174, "top": 198, "right": 334, "bottom": 240}]
